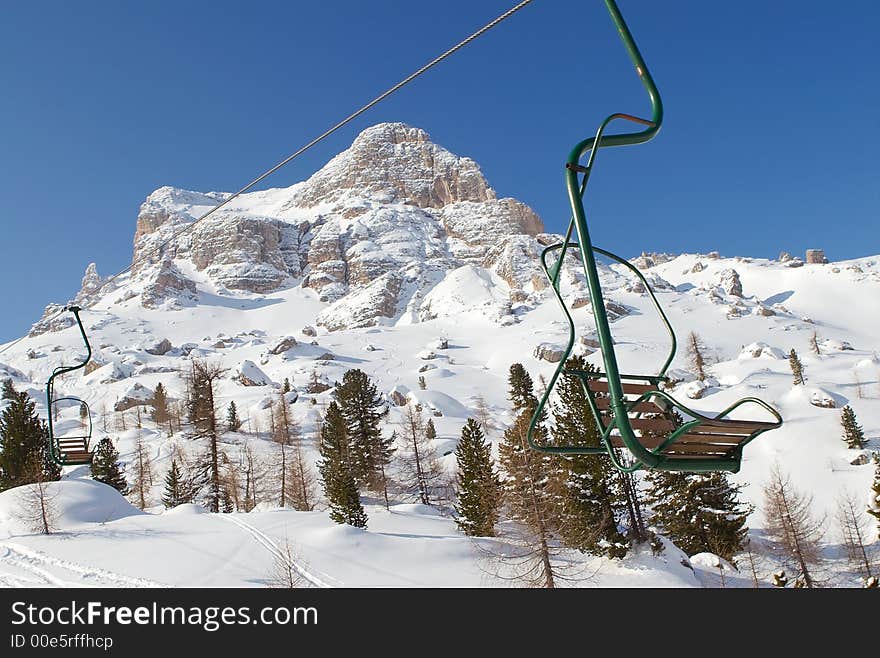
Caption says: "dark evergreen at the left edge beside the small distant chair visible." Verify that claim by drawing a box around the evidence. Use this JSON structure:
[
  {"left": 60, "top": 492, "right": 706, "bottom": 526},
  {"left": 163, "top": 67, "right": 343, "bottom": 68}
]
[{"left": 0, "top": 392, "right": 61, "bottom": 491}]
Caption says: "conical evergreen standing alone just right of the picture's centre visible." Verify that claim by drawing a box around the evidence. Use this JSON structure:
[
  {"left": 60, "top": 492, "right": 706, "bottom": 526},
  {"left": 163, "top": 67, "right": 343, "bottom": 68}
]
[{"left": 455, "top": 418, "right": 501, "bottom": 537}]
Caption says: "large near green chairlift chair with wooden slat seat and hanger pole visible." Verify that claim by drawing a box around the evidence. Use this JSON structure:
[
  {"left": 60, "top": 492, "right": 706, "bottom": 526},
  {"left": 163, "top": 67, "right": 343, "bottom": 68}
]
[{"left": 528, "top": 0, "right": 782, "bottom": 472}]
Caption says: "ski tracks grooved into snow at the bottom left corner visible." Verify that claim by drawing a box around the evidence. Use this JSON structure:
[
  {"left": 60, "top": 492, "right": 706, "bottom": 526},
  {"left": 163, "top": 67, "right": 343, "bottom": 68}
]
[{"left": 0, "top": 542, "right": 167, "bottom": 587}]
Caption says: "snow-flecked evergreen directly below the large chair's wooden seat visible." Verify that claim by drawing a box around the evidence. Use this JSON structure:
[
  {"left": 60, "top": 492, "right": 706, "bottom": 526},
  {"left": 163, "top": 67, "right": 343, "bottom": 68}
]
[{"left": 648, "top": 471, "right": 752, "bottom": 561}]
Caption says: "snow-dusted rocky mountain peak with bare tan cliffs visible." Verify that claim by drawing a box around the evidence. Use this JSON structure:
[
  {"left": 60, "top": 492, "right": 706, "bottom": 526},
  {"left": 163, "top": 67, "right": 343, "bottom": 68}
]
[{"left": 83, "top": 123, "right": 576, "bottom": 329}]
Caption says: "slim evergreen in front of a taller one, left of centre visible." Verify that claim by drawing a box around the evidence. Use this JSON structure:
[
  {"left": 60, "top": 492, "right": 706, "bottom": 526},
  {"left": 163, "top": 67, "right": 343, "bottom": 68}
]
[{"left": 318, "top": 402, "right": 367, "bottom": 528}]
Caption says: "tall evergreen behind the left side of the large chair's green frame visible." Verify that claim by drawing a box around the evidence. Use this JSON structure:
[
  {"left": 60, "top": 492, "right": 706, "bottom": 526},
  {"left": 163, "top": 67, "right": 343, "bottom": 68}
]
[{"left": 553, "top": 356, "right": 627, "bottom": 557}]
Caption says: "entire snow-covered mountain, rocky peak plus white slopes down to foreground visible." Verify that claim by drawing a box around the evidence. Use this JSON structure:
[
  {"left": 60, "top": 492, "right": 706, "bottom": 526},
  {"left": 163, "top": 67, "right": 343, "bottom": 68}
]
[{"left": 0, "top": 124, "right": 880, "bottom": 586}]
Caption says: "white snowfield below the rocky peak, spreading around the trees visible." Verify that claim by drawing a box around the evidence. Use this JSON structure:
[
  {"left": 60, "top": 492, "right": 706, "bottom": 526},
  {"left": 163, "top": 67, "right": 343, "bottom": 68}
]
[{"left": 0, "top": 249, "right": 880, "bottom": 587}]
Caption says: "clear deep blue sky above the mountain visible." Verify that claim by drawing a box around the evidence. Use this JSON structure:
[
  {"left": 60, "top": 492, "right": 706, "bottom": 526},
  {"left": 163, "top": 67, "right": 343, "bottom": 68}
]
[{"left": 0, "top": 0, "right": 880, "bottom": 341}]
